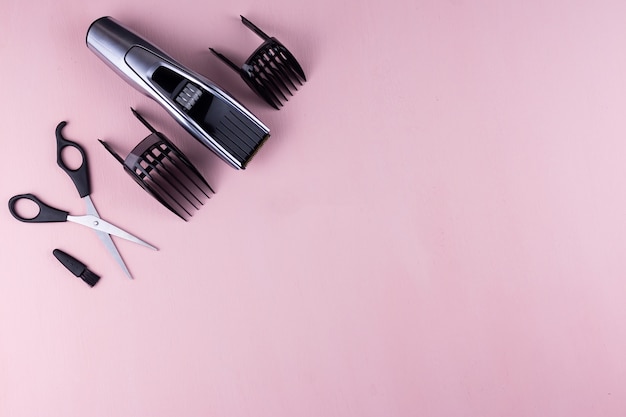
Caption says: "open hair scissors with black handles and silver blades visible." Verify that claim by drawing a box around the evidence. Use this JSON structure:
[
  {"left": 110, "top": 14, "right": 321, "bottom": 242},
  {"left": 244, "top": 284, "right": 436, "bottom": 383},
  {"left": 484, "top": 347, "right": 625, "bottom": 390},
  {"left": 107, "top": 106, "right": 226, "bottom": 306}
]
[{"left": 9, "top": 122, "right": 158, "bottom": 278}]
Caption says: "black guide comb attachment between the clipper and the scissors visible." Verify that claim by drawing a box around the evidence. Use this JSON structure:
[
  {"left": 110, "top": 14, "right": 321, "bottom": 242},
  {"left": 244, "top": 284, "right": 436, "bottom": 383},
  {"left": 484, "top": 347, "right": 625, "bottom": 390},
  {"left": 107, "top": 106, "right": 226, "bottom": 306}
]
[{"left": 100, "top": 108, "right": 215, "bottom": 221}]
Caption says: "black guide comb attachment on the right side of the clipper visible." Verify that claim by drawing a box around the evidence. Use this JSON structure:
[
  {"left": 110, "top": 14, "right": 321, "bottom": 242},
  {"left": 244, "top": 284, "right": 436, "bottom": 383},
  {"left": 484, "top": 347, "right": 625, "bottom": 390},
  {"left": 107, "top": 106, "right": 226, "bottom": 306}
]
[{"left": 209, "top": 16, "right": 306, "bottom": 110}]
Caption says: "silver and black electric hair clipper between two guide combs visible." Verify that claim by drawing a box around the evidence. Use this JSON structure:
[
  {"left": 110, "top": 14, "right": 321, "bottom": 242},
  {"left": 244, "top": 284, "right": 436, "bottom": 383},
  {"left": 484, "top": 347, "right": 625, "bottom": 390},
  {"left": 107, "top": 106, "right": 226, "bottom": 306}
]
[{"left": 87, "top": 17, "right": 269, "bottom": 169}]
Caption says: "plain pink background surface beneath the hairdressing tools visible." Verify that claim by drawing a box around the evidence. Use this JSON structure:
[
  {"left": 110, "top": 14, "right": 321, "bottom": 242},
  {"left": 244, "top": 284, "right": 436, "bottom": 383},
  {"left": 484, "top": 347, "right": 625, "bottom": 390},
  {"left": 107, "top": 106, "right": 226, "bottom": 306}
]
[{"left": 0, "top": 0, "right": 626, "bottom": 417}]
